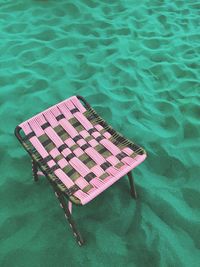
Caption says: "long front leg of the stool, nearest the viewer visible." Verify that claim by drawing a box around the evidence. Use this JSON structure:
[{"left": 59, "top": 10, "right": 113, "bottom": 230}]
[{"left": 53, "top": 186, "right": 84, "bottom": 246}]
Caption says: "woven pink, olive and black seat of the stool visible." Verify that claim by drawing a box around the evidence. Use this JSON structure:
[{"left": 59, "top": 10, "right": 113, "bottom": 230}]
[{"left": 16, "top": 96, "right": 146, "bottom": 205}]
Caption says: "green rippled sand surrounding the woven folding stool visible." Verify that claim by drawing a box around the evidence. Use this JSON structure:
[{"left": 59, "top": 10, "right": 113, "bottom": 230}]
[{"left": 0, "top": 0, "right": 200, "bottom": 267}]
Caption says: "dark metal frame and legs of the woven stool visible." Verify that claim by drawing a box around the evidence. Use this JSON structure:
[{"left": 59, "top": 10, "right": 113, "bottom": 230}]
[{"left": 15, "top": 96, "right": 141, "bottom": 246}]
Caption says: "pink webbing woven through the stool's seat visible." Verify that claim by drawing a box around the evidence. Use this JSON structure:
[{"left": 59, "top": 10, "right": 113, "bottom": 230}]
[{"left": 20, "top": 96, "right": 145, "bottom": 205}]
